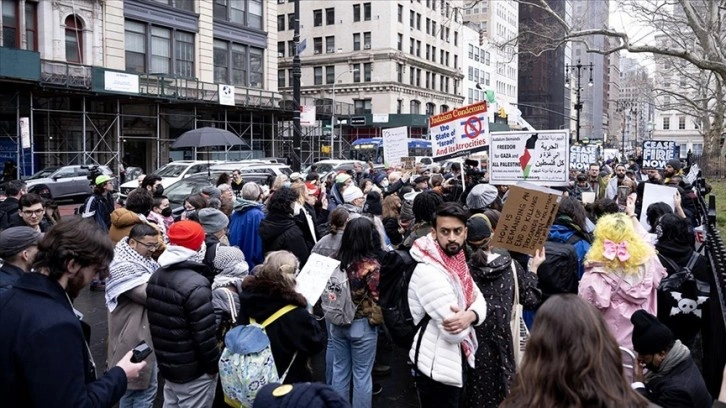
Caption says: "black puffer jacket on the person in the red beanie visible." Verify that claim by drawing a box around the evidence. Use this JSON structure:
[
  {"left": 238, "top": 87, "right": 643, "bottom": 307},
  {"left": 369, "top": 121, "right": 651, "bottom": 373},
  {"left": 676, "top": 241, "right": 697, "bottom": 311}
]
[{"left": 146, "top": 261, "right": 219, "bottom": 384}]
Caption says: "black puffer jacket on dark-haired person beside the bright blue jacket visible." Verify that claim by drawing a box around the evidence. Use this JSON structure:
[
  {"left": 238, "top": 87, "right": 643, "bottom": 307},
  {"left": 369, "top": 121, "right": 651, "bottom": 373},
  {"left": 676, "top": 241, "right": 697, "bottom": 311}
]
[{"left": 259, "top": 212, "right": 312, "bottom": 268}]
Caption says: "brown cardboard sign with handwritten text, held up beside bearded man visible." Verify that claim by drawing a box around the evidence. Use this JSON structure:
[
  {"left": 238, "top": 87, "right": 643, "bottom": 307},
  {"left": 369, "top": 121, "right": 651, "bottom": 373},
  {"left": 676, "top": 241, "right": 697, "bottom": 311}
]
[{"left": 492, "top": 183, "right": 562, "bottom": 255}]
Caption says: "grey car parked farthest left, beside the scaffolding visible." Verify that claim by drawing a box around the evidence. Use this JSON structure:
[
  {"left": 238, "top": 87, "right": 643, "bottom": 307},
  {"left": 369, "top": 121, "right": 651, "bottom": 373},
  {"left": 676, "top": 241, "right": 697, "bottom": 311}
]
[{"left": 25, "top": 165, "right": 114, "bottom": 200}]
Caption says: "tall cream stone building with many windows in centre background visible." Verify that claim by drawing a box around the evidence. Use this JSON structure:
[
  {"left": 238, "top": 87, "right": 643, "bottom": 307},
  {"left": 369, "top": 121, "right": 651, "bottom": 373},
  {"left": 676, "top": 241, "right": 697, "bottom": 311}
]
[{"left": 276, "top": 0, "right": 464, "bottom": 158}]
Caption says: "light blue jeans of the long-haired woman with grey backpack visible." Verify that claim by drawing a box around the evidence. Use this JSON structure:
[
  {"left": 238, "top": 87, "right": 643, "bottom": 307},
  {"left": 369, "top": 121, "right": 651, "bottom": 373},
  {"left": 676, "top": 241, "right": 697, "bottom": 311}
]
[{"left": 330, "top": 318, "right": 378, "bottom": 408}]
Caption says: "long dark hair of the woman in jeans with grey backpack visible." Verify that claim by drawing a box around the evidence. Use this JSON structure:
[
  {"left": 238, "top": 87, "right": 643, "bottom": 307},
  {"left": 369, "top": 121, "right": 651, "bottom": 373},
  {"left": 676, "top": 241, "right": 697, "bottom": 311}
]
[{"left": 336, "top": 217, "right": 381, "bottom": 269}]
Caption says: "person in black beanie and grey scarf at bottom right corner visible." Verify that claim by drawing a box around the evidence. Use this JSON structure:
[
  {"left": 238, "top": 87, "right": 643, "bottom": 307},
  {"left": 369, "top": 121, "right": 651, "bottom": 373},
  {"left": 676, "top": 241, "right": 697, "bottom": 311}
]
[{"left": 630, "top": 310, "right": 712, "bottom": 408}]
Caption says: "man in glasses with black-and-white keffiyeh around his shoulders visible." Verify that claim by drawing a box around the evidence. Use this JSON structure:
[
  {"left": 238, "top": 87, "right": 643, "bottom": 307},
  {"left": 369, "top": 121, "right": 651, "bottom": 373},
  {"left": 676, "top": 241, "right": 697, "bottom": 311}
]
[{"left": 106, "top": 223, "right": 159, "bottom": 408}]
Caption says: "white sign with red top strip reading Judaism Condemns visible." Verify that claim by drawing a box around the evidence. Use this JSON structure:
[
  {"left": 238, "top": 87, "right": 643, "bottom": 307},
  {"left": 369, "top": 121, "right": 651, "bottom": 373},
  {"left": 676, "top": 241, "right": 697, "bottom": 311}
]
[{"left": 429, "top": 102, "right": 489, "bottom": 161}]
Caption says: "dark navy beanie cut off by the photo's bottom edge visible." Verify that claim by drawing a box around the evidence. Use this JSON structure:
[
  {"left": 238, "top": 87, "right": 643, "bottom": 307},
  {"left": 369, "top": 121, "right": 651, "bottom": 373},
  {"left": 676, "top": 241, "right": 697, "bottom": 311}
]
[{"left": 252, "top": 383, "right": 350, "bottom": 408}]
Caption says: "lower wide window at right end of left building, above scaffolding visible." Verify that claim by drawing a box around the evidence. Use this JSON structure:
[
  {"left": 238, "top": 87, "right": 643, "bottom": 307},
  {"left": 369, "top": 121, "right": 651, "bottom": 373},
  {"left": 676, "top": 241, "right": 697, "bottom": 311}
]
[{"left": 214, "top": 40, "right": 264, "bottom": 88}]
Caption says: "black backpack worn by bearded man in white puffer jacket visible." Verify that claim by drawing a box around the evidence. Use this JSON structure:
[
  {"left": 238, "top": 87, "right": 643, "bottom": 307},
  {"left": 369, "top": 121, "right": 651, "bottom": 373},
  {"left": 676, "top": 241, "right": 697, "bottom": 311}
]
[{"left": 378, "top": 249, "right": 425, "bottom": 349}]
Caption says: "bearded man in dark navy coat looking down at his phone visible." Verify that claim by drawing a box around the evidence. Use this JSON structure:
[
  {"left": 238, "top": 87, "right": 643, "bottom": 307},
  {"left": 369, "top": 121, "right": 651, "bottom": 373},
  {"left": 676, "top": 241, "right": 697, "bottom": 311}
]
[{"left": 0, "top": 219, "right": 146, "bottom": 408}]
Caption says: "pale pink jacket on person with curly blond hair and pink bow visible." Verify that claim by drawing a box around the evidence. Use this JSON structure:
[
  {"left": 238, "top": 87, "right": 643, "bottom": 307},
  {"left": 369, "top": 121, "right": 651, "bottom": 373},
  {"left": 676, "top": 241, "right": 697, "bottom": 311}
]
[{"left": 578, "top": 255, "right": 667, "bottom": 350}]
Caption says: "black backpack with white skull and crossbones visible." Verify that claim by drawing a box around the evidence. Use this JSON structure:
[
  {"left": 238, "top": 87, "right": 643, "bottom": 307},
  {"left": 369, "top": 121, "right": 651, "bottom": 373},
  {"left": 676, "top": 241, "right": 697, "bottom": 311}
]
[{"left": 657, "top": 255, "right": 711, "bottom": 339}]
